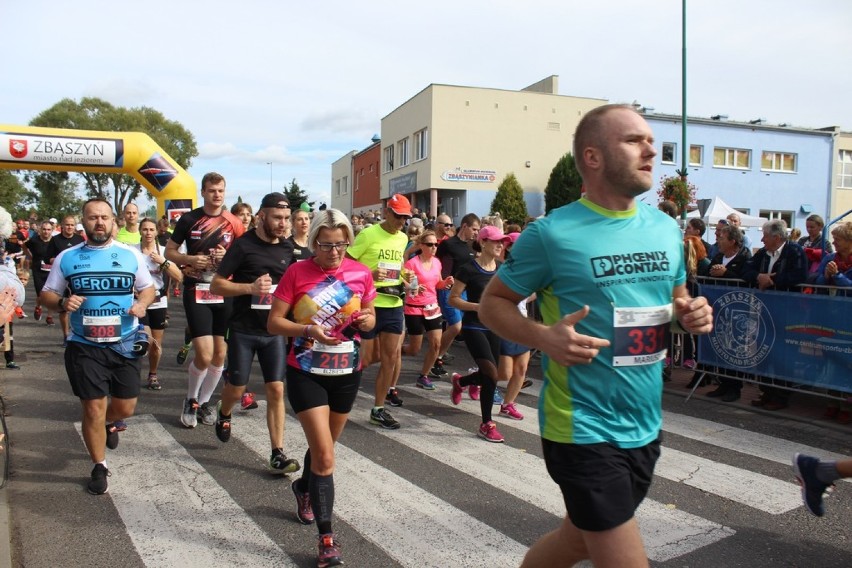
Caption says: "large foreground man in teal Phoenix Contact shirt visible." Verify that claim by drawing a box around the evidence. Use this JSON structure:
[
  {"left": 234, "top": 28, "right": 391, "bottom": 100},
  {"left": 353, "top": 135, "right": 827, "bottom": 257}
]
[{"left": 479, "top": 105, "right": 713, "bottom": 568}]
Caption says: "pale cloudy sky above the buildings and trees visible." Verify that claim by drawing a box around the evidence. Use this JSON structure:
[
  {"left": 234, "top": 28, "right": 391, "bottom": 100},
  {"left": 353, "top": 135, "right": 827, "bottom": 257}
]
[{"left": 0, "top": 0, "right": 852, "bottom": 212}]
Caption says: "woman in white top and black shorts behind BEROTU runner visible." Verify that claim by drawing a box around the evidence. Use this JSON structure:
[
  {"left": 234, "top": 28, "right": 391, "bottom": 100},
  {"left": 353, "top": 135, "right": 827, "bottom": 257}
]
[{"left": 138, "top": 218, "right": 183, "bottom": 390}]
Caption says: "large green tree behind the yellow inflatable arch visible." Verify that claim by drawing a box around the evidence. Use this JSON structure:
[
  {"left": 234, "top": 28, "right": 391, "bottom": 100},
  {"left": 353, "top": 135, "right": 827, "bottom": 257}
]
[{"left": 30, "top": 97, "right": 198, "bottom": 211}]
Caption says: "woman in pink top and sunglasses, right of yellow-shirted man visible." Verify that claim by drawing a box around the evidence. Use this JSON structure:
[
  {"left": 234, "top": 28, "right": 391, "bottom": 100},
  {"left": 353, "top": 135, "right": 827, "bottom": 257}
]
[{"left": 403, "top": 230, "right": 453, "bottom": 390}]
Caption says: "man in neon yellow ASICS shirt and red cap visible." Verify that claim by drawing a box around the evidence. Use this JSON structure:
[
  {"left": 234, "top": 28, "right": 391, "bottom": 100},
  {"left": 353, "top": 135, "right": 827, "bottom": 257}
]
[{"left": 347, "top": 194, "right": 411, "bottom": 430}]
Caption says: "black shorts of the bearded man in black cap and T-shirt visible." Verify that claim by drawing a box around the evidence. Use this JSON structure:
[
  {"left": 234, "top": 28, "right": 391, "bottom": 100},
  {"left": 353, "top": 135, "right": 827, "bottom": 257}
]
[{"left": 225, "top": 330, "right": 287, "bottom": 387}]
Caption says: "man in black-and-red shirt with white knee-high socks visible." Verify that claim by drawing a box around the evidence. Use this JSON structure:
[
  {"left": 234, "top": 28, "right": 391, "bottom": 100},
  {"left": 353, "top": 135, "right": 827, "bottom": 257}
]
[{"left": 166, "top": 172, "right": 243, "bottom": 428}]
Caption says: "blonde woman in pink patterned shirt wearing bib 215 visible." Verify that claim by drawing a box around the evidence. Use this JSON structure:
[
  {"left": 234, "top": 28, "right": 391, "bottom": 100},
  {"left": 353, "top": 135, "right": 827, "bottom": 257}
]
[{"left": 267, "top": 209, "right": 376, "bottom": 566}]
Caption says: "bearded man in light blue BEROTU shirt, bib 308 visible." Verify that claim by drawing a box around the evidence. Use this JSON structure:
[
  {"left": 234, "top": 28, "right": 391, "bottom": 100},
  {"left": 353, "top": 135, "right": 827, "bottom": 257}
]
[{"left": 41, "top": 199, "right": 155, "bottom": 495}]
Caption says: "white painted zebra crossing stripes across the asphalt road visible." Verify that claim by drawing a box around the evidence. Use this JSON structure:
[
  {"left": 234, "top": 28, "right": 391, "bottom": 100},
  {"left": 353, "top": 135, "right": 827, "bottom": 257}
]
[{"left": 77, "top": 384, "right": 825, "bottom": 568}]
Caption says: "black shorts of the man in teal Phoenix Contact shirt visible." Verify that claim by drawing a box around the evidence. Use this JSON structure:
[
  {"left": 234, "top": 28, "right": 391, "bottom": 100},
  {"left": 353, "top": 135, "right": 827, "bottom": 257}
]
[{"left": 541, "top": 439, "right": 660, "bottom": 531}]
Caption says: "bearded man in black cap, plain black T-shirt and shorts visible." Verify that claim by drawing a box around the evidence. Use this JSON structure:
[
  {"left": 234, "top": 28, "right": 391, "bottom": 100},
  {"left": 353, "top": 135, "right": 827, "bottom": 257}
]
[{"left": 210, "top": 192, "right": 299, "bottom": 475}]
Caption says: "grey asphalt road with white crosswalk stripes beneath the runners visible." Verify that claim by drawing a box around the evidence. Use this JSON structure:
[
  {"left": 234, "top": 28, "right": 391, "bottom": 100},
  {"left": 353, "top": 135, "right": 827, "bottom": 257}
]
[{"left": 0, "top": 288, "right": 852, "bottom": 568}]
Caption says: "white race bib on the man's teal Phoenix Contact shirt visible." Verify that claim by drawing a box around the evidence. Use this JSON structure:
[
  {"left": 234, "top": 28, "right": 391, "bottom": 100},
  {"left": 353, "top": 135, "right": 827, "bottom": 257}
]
[{"left": 612, "top": 304, "right": 672, "bottom": 367}]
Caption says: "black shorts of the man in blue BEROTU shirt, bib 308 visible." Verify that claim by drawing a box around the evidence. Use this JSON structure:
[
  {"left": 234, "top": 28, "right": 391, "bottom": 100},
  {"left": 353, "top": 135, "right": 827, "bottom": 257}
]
[{"left": 65, "top": 341, "right": 141, "bottom": 400}]
